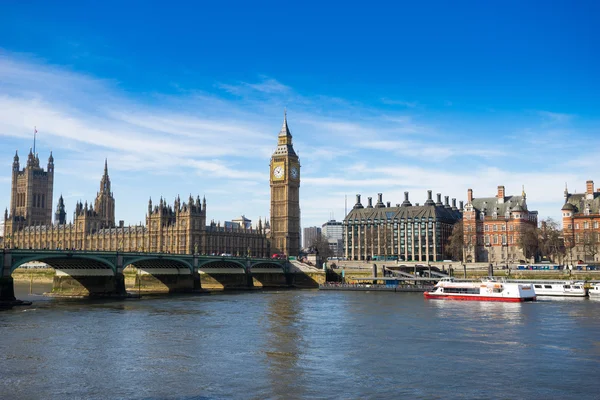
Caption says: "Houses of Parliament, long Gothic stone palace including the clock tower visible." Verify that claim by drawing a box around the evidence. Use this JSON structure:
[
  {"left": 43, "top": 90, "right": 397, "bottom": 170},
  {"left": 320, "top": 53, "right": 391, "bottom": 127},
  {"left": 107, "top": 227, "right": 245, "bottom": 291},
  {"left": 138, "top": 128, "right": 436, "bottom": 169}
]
[{"left": 4, "top": 116, "right": 300, "bottom": 257}]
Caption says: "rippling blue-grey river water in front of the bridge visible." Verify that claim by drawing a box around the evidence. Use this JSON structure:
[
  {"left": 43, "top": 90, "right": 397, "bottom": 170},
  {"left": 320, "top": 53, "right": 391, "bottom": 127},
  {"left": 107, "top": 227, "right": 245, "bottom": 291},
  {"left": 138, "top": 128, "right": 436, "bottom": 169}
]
[{"left": 0, "top": 284, "right": 600, "bottom": 400}]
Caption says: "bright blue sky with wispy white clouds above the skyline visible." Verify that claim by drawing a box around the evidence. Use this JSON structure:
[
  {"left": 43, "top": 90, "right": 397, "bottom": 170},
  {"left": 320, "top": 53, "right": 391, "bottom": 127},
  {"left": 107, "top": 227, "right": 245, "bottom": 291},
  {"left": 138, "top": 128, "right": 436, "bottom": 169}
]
[{"left": 0, "top": 1, "right": 600, "bottom": 231}]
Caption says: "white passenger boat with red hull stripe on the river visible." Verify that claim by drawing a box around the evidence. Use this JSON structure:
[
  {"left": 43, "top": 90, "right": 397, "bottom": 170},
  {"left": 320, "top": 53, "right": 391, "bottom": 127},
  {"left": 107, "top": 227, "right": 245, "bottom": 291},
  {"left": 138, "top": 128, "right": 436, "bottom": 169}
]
[{"left": 424, "top": 278, "right": 535, "bottom": 302}]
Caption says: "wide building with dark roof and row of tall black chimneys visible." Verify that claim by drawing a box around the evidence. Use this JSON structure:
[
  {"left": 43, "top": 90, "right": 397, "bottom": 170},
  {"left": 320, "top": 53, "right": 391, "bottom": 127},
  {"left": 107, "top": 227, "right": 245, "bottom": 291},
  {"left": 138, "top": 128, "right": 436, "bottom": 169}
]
[{"left": 343, "top": 190, "right": 462, "bottom": 262}]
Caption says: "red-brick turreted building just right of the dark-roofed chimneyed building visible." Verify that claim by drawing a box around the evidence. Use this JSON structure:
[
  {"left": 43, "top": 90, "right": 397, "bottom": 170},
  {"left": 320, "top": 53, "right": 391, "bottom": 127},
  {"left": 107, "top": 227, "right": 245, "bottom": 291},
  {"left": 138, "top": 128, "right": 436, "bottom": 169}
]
[{"left": 463, "top": 186, "right": 538, "bottom": 265}]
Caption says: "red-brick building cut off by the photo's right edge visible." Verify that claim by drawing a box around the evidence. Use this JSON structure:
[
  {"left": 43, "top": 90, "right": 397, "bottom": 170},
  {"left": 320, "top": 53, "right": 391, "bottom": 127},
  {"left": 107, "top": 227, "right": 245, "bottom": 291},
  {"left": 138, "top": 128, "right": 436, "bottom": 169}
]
[{"left": 562, "top": 181, "right": 600, "bottom": 264}]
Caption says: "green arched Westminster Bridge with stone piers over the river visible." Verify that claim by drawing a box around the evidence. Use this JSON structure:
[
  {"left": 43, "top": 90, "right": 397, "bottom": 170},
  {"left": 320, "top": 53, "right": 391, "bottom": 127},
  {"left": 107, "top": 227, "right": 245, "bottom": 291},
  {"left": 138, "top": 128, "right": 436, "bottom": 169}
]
[{"left": 0, "top": 249, "right": 322, "bottom": 301}]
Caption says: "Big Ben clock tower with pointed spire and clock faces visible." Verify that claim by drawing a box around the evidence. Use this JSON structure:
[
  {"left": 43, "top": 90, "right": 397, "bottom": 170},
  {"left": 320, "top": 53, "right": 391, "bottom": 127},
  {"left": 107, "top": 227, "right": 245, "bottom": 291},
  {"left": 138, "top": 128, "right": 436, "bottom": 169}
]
[{"left": 270, "top": 114, "right": 300, "bottom": 256}]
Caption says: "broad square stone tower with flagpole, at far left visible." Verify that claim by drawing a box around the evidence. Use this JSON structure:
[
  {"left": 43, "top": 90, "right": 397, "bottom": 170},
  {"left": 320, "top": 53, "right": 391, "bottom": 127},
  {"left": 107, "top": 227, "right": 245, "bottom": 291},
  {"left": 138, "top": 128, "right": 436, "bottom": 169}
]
[{"left": 5, "top": 149, "right": 54, "bottom": 233}]
